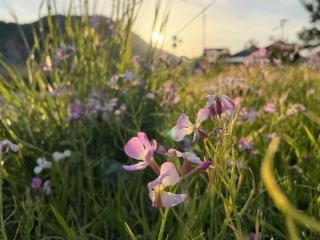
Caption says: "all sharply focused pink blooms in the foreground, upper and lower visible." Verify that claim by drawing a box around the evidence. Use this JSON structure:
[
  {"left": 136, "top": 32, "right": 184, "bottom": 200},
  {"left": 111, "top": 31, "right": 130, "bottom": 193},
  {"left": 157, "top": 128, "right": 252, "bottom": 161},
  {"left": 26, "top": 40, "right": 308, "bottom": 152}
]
[{"left": 123, "top": 95, "right": 235, "bottom": 208}]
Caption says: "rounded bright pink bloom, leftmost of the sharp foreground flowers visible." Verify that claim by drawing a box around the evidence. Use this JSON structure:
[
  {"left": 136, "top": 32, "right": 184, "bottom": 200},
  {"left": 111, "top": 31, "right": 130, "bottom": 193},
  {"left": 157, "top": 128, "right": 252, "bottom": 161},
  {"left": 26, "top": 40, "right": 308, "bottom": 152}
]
[{"left": 123, "top": 132, "right": 157, "bottom": 171}]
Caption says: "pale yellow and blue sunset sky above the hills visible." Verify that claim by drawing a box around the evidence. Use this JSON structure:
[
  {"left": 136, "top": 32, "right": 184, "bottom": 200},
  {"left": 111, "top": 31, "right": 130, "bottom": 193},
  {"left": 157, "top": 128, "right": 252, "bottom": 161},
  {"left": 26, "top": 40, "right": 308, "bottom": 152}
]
[{"left": 0, "top": 0, "right": 310, "bottom": 57}]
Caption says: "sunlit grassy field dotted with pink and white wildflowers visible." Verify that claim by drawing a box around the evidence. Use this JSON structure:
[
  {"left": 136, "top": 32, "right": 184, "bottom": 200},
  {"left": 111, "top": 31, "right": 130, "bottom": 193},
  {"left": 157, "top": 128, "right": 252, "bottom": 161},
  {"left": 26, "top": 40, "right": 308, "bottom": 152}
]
[{"left": 0, "top": 0, "right": 320, "bottom": 240}]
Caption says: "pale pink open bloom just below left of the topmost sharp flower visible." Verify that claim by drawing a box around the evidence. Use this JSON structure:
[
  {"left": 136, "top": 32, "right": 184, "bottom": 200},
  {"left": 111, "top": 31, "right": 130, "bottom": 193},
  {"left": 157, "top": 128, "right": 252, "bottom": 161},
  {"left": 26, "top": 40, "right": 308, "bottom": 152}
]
[{"left": 172, "top": 108, "right": 210, "bottom": 142}]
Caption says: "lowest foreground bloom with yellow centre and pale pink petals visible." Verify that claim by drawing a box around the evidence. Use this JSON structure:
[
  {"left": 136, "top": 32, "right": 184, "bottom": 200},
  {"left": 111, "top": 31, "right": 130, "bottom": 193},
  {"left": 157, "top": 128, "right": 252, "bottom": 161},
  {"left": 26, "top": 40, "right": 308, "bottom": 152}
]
[{"left": 148, "top": 162, "right": 187, "bottom": 208}]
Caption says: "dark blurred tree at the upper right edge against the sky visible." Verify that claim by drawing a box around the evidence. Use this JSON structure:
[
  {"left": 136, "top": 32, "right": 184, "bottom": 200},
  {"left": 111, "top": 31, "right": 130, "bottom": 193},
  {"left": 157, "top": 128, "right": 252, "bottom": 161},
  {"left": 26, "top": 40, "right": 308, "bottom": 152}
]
[{"left": 299, "top": 0, "right": 320, "bottom": 46}]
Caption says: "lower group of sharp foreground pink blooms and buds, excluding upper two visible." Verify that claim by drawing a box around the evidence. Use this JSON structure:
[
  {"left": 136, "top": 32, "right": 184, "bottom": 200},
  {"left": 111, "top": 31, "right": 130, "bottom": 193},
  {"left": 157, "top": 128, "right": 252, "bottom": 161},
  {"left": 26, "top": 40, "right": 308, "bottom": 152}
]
[{"left": 123, "top": 132, "right": 211, "bottom": 208}]
